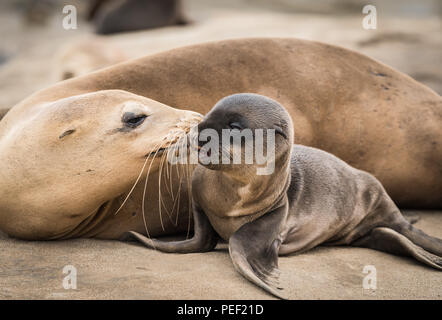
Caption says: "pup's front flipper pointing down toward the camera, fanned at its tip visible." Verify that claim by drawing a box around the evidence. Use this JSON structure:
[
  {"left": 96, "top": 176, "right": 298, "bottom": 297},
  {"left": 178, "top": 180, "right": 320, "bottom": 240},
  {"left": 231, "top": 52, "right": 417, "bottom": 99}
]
[{"left": 229, "top": 203, "right": 288, "bottom": 299}]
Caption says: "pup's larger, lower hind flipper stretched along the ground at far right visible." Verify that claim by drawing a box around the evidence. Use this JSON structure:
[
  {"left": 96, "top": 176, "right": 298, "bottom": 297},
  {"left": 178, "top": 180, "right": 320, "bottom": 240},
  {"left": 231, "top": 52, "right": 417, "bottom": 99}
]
[{"left": 352, "top": 228, "right": 442, "bottom": 270}]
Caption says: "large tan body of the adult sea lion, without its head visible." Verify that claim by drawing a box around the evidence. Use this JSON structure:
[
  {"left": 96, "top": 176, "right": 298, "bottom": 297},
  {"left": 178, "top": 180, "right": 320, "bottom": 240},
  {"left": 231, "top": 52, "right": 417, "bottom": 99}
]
[{"left": 0, "top": 39, "right": 442, "bottom": 238}]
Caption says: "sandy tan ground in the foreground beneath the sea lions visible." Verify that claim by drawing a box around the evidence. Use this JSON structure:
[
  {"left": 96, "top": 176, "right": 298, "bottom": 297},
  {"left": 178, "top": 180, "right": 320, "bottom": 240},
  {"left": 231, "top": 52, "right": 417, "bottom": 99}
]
[{"left": 0, "top": 212, "right": 442, "bottom": 299}]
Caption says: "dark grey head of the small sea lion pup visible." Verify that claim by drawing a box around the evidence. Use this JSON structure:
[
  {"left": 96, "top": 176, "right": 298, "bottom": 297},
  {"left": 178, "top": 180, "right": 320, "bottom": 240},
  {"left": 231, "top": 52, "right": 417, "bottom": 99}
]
[{"left": 198, "top": 93, "right": 294, "bottom": 175}]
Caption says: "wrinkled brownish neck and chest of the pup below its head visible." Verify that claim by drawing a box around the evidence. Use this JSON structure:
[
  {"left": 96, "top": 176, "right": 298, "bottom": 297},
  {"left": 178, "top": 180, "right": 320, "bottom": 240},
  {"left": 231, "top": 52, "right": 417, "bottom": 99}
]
[{"left": 197, "top": 162, "right": 291, "bottom": 240}]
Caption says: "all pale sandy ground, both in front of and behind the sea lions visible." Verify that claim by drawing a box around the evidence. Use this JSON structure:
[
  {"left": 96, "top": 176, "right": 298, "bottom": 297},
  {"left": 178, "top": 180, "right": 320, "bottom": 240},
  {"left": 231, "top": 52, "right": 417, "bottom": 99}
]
[{"left": 0, "top": 0, "right": 442, "bottom": 299}]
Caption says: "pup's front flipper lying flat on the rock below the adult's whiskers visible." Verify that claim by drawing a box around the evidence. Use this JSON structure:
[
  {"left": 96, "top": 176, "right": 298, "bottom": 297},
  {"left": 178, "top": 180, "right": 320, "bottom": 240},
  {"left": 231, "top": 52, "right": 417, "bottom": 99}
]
[{"left": 121, "top": 204, "right": 218, "bottom": 253}]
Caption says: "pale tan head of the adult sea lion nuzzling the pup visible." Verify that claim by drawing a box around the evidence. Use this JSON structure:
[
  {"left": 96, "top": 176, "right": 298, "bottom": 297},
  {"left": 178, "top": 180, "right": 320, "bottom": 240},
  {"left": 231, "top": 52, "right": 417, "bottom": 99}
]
[{"left": 0, "top": 90, "right": 202, "bottom": 237}]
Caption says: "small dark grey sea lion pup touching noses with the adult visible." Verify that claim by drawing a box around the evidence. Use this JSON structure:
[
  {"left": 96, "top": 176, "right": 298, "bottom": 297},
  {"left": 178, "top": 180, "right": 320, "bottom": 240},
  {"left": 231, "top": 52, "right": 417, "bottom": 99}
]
[{"left": 129, "top": 94, "right": 442, "bottom": 297}]
